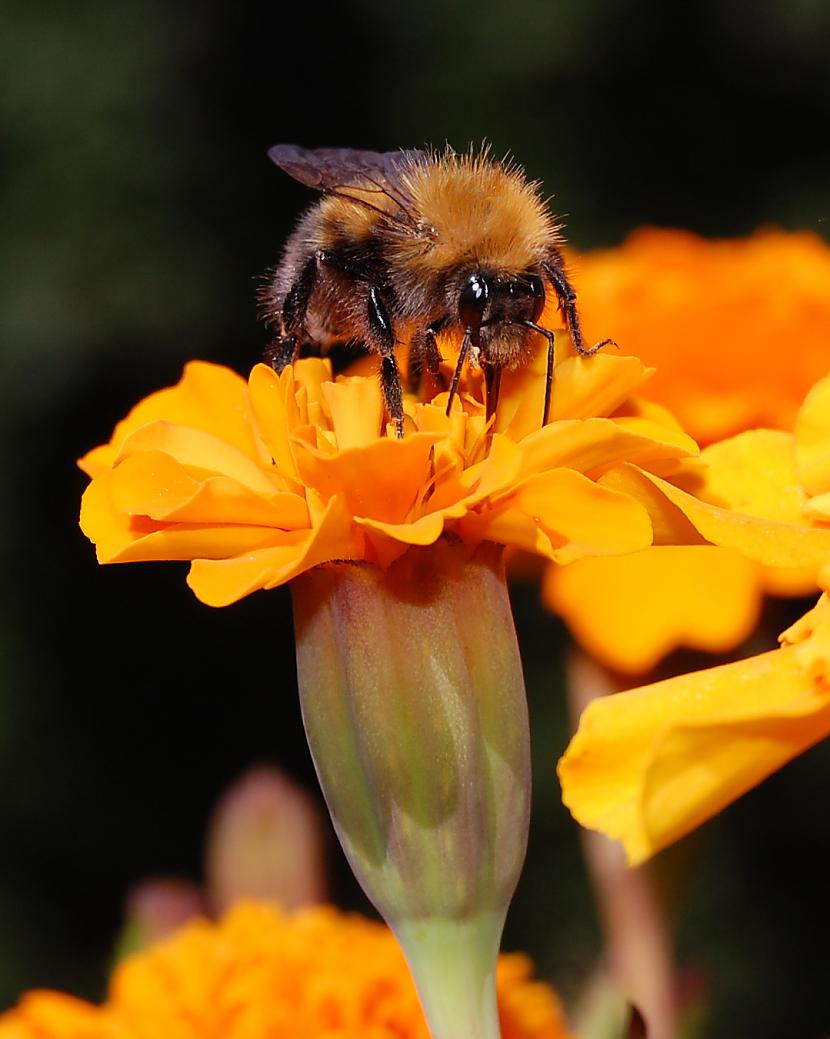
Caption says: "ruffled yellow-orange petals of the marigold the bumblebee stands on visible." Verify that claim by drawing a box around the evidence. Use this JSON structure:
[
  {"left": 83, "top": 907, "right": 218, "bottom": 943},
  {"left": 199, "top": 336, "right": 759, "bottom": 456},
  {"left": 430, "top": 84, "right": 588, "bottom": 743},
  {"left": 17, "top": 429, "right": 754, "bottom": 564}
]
[{"left": 80, "top": 351, "right": 699, "bottom": 606}]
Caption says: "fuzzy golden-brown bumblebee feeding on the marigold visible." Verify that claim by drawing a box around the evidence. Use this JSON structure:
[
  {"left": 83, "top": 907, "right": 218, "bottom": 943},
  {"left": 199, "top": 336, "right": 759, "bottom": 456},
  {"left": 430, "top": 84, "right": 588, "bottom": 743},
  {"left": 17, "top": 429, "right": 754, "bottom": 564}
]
[{"left": 260, "top": 144, "right": 612, "bottom": 436}]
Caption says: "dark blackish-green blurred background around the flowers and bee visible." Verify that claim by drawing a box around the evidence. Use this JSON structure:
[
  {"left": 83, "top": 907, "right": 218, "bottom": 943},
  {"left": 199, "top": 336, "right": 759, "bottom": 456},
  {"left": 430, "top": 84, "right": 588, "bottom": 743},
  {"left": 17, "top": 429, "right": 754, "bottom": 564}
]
[{"left": 0, "top": 0, "right": 830, "bottom": 1039}]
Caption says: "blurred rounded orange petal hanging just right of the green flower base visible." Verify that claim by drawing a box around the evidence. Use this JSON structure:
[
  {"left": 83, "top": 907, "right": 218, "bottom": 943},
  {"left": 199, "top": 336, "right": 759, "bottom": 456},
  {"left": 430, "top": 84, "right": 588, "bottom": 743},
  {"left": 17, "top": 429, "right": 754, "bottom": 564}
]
[{"left": 542, "top": 545, "right": 764, "bottom": 674}]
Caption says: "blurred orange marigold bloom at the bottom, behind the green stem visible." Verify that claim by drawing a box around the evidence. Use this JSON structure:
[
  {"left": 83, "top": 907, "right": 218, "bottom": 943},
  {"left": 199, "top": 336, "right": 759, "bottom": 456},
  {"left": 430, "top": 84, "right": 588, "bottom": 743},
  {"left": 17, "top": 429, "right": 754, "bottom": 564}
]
[{"left": 0, "top": 903, "right": 568, "bottom": 1039}]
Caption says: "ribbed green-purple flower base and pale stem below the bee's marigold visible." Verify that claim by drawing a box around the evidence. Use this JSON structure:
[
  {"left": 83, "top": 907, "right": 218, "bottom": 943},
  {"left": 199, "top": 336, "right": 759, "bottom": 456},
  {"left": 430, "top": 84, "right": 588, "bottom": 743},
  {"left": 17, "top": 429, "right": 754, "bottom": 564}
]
[{"left": 292, "top": 540, "right": 530, "bottom": 1039}]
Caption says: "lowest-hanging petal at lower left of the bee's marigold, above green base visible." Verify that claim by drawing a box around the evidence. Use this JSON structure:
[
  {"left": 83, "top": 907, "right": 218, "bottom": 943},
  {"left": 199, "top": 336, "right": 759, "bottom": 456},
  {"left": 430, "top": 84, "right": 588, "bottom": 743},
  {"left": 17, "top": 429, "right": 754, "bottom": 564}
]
[{"left": 187, "top": 498, "right": 364, "bottom": 606}]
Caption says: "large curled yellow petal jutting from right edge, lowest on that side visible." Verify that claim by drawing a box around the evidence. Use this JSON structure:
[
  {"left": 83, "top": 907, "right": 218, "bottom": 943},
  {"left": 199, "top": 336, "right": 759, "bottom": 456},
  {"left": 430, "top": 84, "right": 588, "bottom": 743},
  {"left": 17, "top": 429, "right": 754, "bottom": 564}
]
[{"left": 559, "top": 646, "right": 830, "bottom": 864}]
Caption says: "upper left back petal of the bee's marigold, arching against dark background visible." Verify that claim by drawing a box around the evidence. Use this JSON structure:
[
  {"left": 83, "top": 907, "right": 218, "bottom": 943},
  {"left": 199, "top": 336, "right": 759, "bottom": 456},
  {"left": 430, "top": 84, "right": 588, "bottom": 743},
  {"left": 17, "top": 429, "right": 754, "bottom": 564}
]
[{"left": 78, "top": 361, "right": 262, "bottom": 476}]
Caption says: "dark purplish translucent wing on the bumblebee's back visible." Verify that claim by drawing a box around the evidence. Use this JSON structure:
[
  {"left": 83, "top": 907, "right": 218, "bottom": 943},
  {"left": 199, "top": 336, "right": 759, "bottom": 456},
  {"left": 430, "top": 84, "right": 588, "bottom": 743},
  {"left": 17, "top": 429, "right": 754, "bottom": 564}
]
[{"left": 268, "top": 144, "right": 426, "bottom": 192}]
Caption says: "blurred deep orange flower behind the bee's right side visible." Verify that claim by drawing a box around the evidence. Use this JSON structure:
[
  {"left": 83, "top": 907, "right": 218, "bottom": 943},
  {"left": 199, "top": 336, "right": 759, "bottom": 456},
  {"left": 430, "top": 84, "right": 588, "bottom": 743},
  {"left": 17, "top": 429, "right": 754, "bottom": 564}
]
[{"left": 573, "top": 229, "right": 830, "bottom": 444}]
